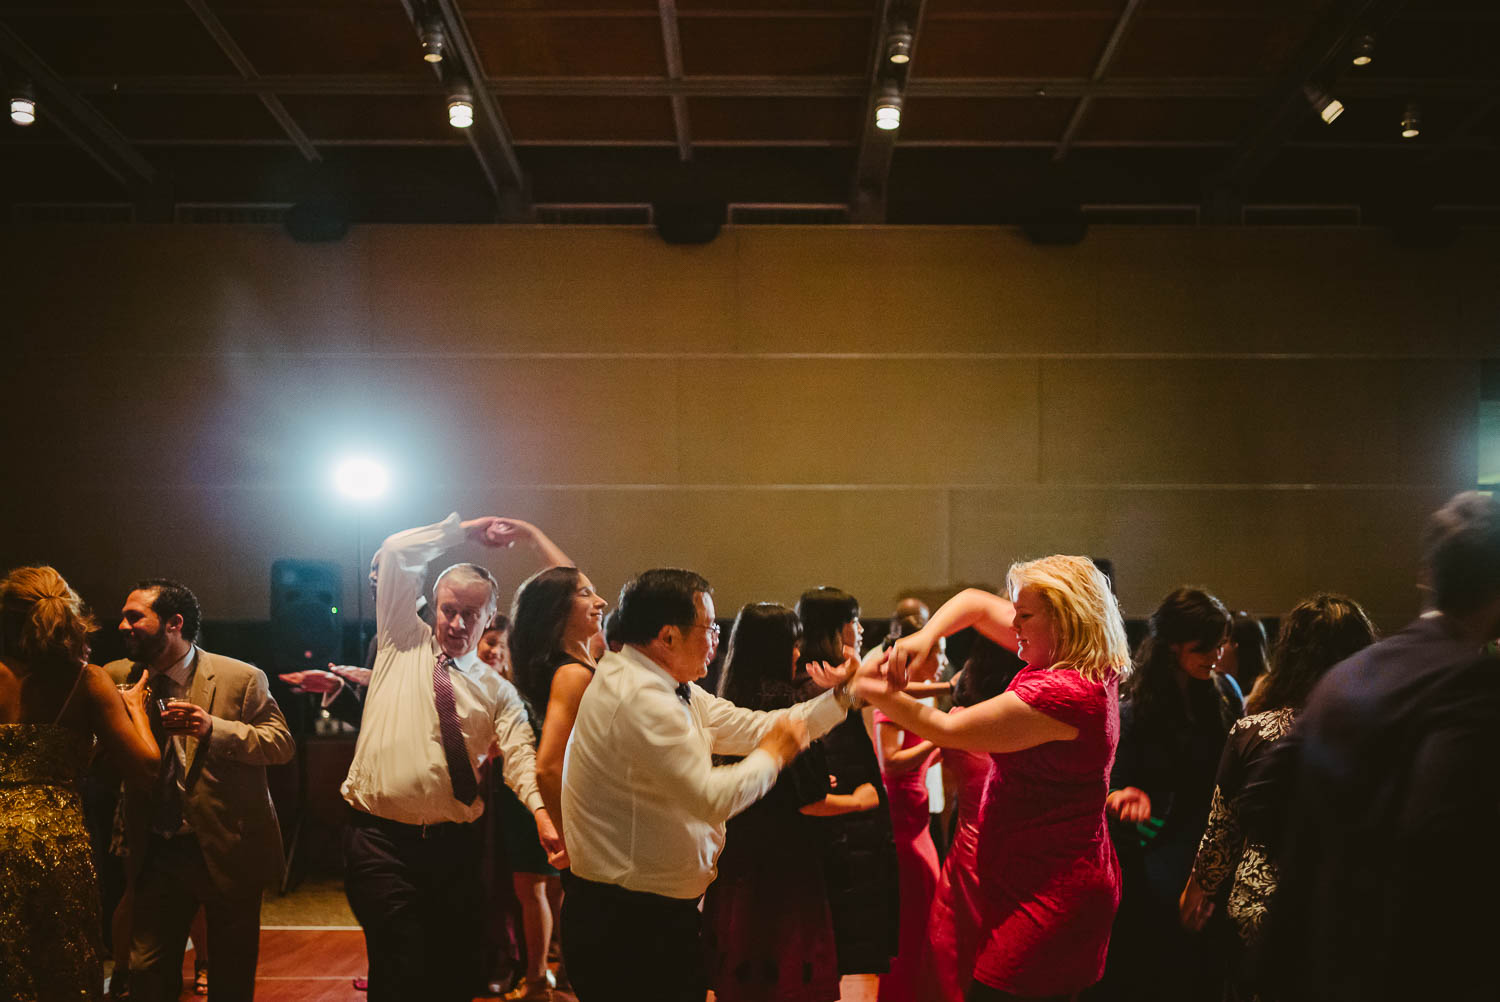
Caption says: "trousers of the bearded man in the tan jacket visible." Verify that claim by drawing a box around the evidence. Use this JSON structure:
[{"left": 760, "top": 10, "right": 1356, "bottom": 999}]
[{"left": 131, "top": 834, "right": 261, "bottom": 1002}]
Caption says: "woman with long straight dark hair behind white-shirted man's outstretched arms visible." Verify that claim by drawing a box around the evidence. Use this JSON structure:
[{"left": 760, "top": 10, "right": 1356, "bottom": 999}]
[{"left": 704, "top": 603, "right": 881, "bottom": 1002}]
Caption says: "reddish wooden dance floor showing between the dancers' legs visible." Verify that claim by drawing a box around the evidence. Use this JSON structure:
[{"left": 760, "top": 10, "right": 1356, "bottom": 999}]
[{"left": 171, "top": 929, "right": 876, "bottom": 1002}]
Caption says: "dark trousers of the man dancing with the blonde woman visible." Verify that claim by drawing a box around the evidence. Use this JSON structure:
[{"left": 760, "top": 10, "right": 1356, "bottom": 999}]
[{"left": 563, "top": 875, "right": 708, "bottom": 1002}]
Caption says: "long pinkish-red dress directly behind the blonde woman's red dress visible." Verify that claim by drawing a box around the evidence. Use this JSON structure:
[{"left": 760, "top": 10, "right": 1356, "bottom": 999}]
[{"left": 929, "top": 707, "right": 990, "bottom": 1002}]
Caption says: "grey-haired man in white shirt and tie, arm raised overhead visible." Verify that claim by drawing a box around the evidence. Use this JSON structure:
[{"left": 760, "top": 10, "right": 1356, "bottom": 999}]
[{"left": 342, "top": 513, "right": 569, "bottom": 1002}]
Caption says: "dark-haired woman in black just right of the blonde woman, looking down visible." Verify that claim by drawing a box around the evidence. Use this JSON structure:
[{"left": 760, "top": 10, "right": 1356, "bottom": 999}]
[{"left": 1106, "top": 588, "right": 1244, "bottom": 1002}]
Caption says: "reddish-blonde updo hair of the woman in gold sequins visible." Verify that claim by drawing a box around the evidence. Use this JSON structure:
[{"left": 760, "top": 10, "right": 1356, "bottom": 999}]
[{"left": 0, "top": 567, "right": 96, "bottom": 668}]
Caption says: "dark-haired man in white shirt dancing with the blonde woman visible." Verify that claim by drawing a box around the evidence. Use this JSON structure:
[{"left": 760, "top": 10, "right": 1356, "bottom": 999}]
[{"left": 563, "top": 570, "right": 849, "bottom": 1002}]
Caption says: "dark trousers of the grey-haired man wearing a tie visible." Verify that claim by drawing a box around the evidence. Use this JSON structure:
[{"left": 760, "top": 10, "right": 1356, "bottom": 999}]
[{"left": 343, "top": 809, "right": 483, "bottom": 1002}]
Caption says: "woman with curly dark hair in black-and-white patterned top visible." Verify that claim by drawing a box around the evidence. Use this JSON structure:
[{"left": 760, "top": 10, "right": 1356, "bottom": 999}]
[{"left": 1179, "top": 594, "right": 1376, "bottom": 1001}]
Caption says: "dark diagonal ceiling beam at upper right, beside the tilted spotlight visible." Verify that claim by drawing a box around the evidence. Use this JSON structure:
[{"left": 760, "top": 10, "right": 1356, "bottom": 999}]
[{"left": 1203, "top": 0, "right": 1404, "bottom": 222}]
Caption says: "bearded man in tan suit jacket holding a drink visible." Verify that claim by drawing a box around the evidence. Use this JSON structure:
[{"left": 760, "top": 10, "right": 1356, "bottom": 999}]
[{"left": 107, "top": 579, "right": 294, "bottom": 1002}]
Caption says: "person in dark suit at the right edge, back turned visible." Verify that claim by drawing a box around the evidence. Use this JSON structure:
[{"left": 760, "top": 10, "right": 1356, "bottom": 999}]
[{"left": 1236, "top": 492, "right": 1500, "bottom": 1002}]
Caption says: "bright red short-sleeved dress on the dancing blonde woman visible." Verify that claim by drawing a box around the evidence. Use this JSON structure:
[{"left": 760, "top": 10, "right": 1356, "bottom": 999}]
[{"left": 974, "top": 668, "right": 1121, "bottom": 996}]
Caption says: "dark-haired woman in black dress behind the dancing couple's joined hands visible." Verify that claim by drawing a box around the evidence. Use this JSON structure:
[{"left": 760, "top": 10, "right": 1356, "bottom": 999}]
[{"left": 797, "top": 587, "right": 900, "bottom": 975}]
